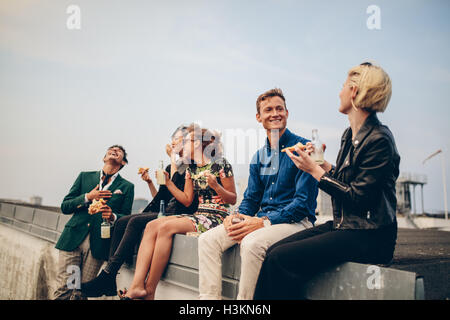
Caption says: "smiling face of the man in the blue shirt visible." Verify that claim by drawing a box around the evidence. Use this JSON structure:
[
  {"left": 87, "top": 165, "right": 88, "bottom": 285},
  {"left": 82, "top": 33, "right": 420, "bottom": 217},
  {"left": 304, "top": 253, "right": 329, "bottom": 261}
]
[{"left": 256, "top": 96, "right": 289, "bottom": 133}]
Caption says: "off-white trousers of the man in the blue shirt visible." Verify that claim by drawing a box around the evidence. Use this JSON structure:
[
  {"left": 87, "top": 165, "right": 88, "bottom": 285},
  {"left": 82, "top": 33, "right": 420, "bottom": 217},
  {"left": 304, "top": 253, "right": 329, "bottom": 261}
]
[{"left": 198, "top": 218, "right": 313, "bottom": 300}]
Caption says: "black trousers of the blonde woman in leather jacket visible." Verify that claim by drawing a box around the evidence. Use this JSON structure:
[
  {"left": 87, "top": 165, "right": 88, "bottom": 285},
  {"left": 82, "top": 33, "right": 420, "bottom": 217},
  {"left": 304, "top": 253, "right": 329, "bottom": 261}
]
[{"left": 254, "top": 221, "right": 397, "bottom": 300}]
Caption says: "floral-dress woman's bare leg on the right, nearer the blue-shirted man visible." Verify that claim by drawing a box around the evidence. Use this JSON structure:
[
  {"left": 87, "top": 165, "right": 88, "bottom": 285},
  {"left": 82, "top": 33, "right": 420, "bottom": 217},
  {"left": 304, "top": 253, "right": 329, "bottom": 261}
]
[{"left": 145, "top": 218, "right": 195, "bottom": 300}]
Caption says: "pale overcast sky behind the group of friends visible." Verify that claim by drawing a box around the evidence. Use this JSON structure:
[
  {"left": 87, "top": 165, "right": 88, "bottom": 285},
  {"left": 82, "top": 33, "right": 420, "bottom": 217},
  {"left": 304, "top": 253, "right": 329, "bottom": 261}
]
[{"left": 0, "top": 0, "right": 450, "bottom": 210}]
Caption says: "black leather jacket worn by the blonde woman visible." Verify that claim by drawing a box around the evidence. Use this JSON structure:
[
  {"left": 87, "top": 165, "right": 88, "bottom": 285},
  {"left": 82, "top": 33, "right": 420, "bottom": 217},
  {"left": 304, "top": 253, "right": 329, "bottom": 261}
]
[{"left": 318, "top": 113, "right": 400, "bottom": 229}]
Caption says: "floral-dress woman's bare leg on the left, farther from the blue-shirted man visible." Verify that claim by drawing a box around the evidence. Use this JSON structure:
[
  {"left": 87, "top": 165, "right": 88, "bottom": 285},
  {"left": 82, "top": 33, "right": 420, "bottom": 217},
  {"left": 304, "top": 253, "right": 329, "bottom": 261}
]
[{"left": 126, "top": 217, "right": 175, "bottom": 299}]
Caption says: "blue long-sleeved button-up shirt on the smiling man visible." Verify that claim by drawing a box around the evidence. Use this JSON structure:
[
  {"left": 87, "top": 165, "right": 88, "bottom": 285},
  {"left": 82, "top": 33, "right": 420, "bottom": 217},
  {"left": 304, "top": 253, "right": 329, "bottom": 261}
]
[{"left": 239, "top": 129, "right": 318, "bottom": 224}]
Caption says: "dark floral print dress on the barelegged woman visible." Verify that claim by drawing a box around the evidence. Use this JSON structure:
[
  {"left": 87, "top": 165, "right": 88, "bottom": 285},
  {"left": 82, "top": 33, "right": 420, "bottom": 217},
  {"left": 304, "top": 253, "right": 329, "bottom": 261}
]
[{"left": 184, "top": 158, "right": 233, "bottom": 232}]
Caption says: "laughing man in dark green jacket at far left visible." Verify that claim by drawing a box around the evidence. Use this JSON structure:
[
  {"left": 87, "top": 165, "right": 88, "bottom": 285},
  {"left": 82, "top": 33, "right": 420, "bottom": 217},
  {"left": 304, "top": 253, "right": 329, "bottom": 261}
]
[{"left": 54, "top": 145, "right": 134, "bottom": 300}]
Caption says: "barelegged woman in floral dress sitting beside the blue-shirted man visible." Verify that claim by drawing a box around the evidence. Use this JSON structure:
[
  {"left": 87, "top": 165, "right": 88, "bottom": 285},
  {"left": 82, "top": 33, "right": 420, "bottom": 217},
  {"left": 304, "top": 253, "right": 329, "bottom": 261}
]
[{"left": 119, "top": 128, "right": 236, "bottom": 300}]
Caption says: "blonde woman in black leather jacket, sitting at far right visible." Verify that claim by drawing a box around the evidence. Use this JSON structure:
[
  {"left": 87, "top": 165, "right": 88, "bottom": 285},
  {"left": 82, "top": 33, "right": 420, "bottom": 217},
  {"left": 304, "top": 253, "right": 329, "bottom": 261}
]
[{"left": 254, "top": 62, "right": 400, "bottom": 300}]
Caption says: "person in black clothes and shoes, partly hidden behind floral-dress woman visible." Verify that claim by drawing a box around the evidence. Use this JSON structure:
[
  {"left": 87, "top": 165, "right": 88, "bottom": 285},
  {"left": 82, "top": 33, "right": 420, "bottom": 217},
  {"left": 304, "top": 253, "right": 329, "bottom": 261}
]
[{"left": 81, "top": 125, "right": 198, "bottom": 297}]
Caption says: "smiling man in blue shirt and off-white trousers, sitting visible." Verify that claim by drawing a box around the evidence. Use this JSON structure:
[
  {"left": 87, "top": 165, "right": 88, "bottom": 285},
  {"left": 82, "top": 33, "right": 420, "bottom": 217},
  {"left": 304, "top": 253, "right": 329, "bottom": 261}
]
[{"left": 198, "top": 89, "right": 318, "bottom": 300}]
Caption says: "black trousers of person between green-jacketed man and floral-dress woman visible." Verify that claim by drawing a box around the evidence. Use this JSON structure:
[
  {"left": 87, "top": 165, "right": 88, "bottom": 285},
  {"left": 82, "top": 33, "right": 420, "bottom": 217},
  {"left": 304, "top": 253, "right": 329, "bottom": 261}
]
[{"left": 105, "top": 212, "right": 158, "bottom": 274}]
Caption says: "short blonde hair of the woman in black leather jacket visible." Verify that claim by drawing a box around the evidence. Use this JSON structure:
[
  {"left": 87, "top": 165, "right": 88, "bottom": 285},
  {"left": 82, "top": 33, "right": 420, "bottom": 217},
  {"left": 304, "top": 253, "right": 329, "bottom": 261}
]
[{"left": 348, "top": 62, "right": 392, "bottom": 112}]
